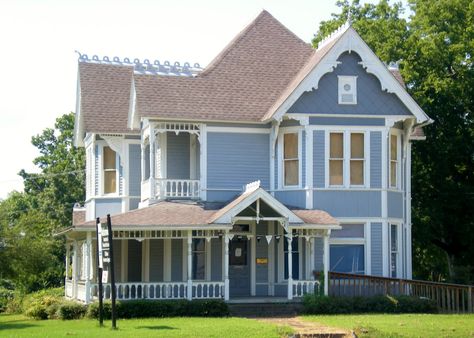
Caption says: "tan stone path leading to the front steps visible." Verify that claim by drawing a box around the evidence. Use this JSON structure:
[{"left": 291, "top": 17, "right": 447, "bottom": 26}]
[{"left": 256, "top": 317, "right": 356, "bottom": 338}]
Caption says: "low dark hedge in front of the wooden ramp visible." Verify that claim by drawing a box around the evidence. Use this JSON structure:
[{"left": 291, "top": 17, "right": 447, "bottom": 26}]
[{"left": 303, "top": 294, "right": 438, "bottom": 314}]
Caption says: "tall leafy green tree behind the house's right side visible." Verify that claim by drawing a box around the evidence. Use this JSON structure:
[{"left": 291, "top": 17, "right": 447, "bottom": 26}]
[{"left": 313, "top": 0, "right": 474, "bottom": 282}]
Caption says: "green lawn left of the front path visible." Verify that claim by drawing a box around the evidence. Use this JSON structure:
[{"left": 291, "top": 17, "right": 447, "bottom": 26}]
[{"left": 0, "top": 314, "right": 291, "bottom": 338}]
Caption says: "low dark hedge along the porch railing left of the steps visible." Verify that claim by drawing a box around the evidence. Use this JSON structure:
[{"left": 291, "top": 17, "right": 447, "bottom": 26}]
[{"left": 86, "top": 300, "right": 229, "bottom": 319}]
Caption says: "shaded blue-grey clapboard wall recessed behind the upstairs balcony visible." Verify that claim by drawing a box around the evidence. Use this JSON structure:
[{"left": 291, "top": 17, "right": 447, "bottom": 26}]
[{"left": 166, "top": 133, "right": 190, "bottom": 179}]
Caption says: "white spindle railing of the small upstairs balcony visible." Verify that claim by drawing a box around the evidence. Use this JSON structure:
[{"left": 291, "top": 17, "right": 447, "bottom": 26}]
[{"left": 156, "top": 178, "right": 201, "bottom": 199}]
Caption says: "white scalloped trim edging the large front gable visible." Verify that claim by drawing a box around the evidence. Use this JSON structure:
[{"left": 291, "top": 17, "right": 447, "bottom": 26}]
[{"left": 273, "top": 27, "right": 429, "bottom": 123}]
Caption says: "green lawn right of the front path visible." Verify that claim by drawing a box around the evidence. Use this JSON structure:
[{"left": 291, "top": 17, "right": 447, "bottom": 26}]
[{"left": 303, "top": 314, "right": 474, "bottom": 338}]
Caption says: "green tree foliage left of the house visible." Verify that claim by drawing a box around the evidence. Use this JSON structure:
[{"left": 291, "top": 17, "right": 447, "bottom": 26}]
[{"left": 0, "top": 113, "right": 85, "bottom": 291}]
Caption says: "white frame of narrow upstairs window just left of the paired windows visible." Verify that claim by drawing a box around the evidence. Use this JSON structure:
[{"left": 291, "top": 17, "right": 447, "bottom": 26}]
[{"left": 278, "top": 127, "right": 303, "bottom": 189}]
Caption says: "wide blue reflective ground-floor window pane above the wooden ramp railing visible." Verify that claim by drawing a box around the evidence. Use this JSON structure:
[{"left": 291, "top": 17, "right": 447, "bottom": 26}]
[{"left": 329, "top": 244, "right": 365, "bottom": 274}]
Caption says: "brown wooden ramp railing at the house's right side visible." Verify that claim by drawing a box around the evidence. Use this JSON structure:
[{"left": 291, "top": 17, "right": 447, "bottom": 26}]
[{"left": 329, "top": 272, "right": 474, "bottom": 313}]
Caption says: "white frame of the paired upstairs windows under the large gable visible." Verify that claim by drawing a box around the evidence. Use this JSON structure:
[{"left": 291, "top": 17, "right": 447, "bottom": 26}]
[{"left": 325, "top": 129, "right": 370, "bottom": 189}]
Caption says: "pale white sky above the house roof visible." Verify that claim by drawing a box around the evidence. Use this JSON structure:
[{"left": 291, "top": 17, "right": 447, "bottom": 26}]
[{"left": 0, "top": 0, "right": 386, "bottom": 199}]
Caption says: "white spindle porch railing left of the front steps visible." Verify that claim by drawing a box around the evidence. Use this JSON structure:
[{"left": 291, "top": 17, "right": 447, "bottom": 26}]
[{"left": 91, "top": 282, "right": 224, "bottom": 300}]
